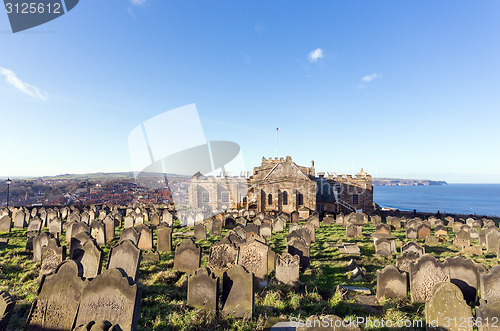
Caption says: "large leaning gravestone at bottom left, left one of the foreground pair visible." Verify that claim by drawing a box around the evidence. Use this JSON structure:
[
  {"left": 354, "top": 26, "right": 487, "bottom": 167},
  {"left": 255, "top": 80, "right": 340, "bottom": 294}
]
[{"left": 26, "top": 260, "right": 85, "bottom": 330}]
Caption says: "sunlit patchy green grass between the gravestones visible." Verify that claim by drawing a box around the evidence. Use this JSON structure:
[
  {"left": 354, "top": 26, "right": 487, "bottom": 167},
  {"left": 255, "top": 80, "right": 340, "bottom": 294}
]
[{"left": 0, "top": 218, "right": 498, "bottom": 330}]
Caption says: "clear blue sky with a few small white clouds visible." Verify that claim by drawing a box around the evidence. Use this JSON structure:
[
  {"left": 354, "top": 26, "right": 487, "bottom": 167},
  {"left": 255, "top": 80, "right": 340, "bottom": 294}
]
[{"left": 0, "top": 0, "right": 500, "bottom": 183}]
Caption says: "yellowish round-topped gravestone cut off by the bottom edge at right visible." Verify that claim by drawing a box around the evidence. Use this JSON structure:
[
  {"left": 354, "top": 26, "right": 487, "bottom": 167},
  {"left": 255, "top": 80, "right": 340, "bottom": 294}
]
[{"left": 425, "top": 282, "right": 473, "bottom": 331}]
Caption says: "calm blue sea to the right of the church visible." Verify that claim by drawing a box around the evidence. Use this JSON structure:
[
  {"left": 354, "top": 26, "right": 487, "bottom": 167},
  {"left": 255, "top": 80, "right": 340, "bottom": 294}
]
[{"left": 373, "top": 184, "right": 500, "bottom": 217}]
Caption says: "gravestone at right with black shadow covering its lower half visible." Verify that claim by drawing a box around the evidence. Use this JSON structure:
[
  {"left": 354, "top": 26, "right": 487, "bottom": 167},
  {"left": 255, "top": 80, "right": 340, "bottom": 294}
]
[{"left": 446, "top": 256, "right": 479, "bottom": 303}]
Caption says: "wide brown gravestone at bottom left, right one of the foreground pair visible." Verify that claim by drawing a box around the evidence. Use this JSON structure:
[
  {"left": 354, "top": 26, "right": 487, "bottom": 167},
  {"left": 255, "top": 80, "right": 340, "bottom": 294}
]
[{"left": 76, "top": 268, "right": 141, "bottom": 330}]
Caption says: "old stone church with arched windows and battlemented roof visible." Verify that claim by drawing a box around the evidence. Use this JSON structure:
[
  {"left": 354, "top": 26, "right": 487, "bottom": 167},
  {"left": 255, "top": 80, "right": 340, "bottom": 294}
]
[{"left": 188, "top": 156, "right": 374, "bottom": 214}]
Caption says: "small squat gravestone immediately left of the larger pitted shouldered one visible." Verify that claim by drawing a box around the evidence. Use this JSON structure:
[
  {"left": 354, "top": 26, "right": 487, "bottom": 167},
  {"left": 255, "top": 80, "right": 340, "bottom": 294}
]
[{"left": 377, "top": 265, "right": 408, "bottom": 300}]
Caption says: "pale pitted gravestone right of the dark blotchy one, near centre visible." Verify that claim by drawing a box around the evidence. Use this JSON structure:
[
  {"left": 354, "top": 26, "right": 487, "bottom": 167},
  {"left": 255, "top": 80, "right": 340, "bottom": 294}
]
[{"left": 238, "top": 239, "right": 269, "bottom": 287}]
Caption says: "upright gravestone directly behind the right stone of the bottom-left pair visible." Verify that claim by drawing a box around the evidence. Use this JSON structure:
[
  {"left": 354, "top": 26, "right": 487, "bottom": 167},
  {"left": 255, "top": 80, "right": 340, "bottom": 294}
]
[{"left": 107, "top": 239, "right": 142, "bottom": 282}]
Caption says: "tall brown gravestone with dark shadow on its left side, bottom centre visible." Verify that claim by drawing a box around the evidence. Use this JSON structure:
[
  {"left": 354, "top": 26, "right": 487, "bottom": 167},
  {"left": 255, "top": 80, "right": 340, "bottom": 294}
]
[{"left": 222, "top": 265, "right": 255, "bottom": 319}]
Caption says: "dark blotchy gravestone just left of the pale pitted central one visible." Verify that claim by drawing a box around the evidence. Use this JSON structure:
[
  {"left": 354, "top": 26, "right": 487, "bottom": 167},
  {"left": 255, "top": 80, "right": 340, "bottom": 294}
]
[{"left": 208, "top": 237, "right": 238, "bottom": 277}]
